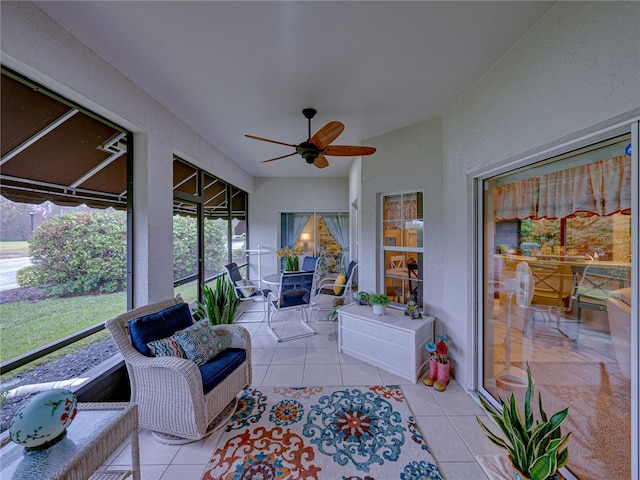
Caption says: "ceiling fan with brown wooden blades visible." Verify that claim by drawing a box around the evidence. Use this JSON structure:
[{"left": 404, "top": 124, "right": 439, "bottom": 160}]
[{"left": 245, "top": 108, "right": 376, "bottom": 168}]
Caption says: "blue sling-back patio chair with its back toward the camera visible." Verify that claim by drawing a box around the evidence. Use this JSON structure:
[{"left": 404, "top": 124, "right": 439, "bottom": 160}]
[{"left": 267, "top": 272, "right": 317, "bottom": 342}]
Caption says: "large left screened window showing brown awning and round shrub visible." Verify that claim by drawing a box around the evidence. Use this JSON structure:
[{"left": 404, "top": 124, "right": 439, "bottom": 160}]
[{"left": 0, "top": 67, "right": 133, "bottom": 430}]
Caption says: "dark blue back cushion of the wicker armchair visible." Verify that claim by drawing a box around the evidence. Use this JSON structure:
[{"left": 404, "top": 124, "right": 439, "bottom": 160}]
[{"left": 127, "top": 303, "right": 193, "bottom": 357}]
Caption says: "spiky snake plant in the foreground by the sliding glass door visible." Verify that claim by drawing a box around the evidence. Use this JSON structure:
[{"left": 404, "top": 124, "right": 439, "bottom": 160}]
[{"left": 476, "top": 363, "right": 571, "bottom": 480}]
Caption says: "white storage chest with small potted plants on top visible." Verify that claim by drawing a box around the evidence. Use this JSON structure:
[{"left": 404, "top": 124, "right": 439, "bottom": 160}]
[{"left": 338, "top": 303, "right": 435, "bottom": 383}]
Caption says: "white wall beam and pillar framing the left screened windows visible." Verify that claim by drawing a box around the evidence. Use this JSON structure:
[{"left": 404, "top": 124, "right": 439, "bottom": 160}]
[{"left": 0, "top": 2, "right": 253, "bottom": 305}]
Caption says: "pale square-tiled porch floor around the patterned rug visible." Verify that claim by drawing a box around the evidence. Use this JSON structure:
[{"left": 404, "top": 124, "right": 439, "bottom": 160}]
[{"left": 99, "top": 312, "right": 503, "bottom": 480}]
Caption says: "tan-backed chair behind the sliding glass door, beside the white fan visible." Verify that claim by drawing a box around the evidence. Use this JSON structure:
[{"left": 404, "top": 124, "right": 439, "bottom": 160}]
[{"left": 524, "top": 262, "right": 578, "bottom": 348}]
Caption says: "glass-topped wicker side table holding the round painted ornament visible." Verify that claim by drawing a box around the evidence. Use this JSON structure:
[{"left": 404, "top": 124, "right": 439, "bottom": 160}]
[{"left": 0, "top": 403, "right": 140, "bottom": 480}]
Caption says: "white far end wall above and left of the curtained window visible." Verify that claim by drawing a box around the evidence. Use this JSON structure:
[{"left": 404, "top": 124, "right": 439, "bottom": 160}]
[{"left": 249, "top": 177, "right": 349, "bottom": 279}]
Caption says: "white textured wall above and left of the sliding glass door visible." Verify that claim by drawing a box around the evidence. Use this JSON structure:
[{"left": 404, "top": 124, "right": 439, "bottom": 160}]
[{"left": 440, "top": 2, "right": 640, "bottom": 389}]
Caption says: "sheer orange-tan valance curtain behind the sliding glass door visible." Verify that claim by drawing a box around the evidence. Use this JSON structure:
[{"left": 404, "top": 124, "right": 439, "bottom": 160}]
[{"left": 494, "top": 155, "right": 631, "bottom": 221}]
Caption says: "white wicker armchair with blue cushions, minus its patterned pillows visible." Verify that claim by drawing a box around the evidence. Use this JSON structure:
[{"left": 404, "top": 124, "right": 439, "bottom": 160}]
[{"left": 105, "top": 296, "right": 251, "bottom": 444}]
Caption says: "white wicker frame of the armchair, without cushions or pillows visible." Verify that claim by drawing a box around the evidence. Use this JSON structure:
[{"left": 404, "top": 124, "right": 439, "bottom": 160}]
[{"left": 105, "top": 296, "right": 251, "bottom": 444}]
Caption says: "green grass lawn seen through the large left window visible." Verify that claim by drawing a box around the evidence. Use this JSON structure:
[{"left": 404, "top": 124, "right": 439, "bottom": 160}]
[{"left": 0, "top": 292, "right": 127, "bottom": 376}]
